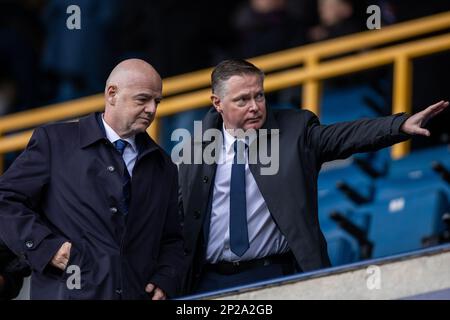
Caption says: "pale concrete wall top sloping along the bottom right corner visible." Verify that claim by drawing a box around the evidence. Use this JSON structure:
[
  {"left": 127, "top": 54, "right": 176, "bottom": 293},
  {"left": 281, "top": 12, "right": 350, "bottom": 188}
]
[{"left": 209, "top": 247, "right": 450, "bottom": 300}]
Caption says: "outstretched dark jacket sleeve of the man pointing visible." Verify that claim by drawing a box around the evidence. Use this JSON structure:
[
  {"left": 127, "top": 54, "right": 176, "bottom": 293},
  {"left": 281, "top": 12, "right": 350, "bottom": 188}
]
[{"left": 306, "top": 112, "right": 411, "bottom": 163}]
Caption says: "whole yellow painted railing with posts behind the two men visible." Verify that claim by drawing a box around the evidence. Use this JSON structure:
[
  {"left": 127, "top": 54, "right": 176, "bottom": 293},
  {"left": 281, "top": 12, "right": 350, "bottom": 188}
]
[{"left": 0, "top": 12, "right": 450, "bottom": 169}]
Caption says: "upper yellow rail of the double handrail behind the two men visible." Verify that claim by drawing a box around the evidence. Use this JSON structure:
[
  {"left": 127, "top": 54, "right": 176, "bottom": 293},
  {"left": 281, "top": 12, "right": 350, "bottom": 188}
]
[{"left": 0, "top": 12, "right": 450, "bottom": 134}]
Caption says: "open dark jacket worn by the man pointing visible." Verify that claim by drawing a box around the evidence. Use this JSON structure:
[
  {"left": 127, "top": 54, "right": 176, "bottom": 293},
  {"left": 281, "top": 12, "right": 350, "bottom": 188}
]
[{"left": 179, "top": 109, "right": 409, "bottom": 288}]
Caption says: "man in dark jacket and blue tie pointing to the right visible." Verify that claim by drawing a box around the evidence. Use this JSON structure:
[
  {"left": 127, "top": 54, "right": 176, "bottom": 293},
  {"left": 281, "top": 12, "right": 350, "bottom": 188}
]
[{"left": 179, "top": 60, "right": 448, "bottom": 293}]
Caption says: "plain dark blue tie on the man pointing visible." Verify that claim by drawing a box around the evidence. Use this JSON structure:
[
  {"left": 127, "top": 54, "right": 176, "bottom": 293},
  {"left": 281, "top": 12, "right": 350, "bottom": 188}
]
[{"left": 230, "top": 140, "right": 250, "bottom": 257}]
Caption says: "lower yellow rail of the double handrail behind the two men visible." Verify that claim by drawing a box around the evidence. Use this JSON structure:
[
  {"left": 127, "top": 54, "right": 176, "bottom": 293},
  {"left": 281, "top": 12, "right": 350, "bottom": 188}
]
[{"left": 0, "top": 33, "right": 450, "bottom": 153}]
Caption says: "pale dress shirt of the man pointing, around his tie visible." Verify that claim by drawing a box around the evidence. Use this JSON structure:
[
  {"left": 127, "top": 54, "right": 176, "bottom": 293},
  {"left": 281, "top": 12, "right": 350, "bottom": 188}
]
[{"left": 206, "top": 128, "right": 289, "bottom": 263}]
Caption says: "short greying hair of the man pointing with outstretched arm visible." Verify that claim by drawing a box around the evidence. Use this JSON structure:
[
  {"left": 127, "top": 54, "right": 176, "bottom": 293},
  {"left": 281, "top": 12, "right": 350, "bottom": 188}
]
[{"left": 211, "top": 60, "right": 264, "bottom": 96}]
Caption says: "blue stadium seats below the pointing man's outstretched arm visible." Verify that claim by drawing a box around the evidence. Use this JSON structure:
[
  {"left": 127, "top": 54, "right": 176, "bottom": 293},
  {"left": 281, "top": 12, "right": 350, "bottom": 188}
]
[{"left": 318, "top": 146, "right": 450, "bottom": 265}]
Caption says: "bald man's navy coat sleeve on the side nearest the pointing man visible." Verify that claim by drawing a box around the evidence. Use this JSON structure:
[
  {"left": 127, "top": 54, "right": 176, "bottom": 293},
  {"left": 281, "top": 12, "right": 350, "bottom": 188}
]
[{"left": 149, "top": 169, "right": 186, "bottom": 298}]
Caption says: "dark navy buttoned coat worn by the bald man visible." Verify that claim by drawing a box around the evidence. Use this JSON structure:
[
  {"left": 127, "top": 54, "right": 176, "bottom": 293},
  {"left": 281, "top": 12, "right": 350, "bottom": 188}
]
[{"left": 0, "top": 114, "right": 184, "bottom": 299}]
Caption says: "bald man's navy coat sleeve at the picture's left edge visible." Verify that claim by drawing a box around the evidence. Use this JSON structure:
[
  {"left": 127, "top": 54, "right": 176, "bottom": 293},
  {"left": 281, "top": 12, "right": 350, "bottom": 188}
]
[{"left": 0, "top": 128, "right": 67, "bottom": 272}]
